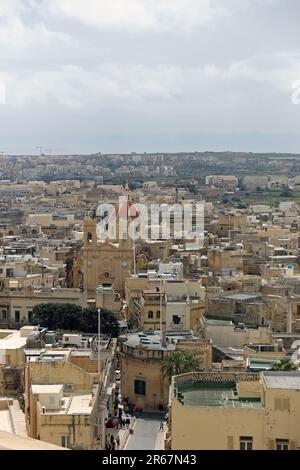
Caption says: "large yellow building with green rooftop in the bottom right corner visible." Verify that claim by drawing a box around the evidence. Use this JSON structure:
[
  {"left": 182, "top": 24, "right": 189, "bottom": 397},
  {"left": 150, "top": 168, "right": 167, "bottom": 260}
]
[{"left": 166, "top": 371, "right": 300, "bottom": 450}]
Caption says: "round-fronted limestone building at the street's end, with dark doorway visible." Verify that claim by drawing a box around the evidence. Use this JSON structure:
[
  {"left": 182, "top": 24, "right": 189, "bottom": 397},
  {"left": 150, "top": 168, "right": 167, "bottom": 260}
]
[{"left": 120, "top": 331, "right": 212, "bottom": 411}]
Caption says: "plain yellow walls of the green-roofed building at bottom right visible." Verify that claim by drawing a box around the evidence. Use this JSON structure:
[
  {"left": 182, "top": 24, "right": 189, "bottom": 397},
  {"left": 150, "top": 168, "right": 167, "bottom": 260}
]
[{"left": 170, "top": 382, "right": 300, "bottom": 450}]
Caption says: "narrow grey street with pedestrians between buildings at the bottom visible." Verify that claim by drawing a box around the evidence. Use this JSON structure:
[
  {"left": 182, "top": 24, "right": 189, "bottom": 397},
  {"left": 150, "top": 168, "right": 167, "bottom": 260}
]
[{"left": 124, "top": 417, "right": 164, "bottom": 450}]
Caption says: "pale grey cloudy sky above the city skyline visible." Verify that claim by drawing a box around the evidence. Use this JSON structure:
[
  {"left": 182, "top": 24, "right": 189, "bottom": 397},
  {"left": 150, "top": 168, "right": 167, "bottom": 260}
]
[{"left": 0, "top": 0, "right": 300, "bottom": 153}]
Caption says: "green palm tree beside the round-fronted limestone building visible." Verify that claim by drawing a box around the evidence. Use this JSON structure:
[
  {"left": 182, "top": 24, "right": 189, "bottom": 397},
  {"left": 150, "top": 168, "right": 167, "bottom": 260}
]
[{"left": 162, "top": 351, "right": 199, "bottom": 382}]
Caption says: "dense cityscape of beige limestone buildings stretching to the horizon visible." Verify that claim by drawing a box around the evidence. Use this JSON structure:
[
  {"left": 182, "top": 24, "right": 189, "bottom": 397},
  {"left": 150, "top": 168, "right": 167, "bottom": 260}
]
[{"left": 0, "top": 152, "right": 300, "bottom": 450}]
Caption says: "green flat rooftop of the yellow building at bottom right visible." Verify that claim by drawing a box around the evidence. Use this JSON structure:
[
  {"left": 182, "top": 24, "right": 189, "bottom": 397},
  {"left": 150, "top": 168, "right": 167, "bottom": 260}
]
[{"left": 177, "top": 382, "right": 262, "bottom": 409}]
